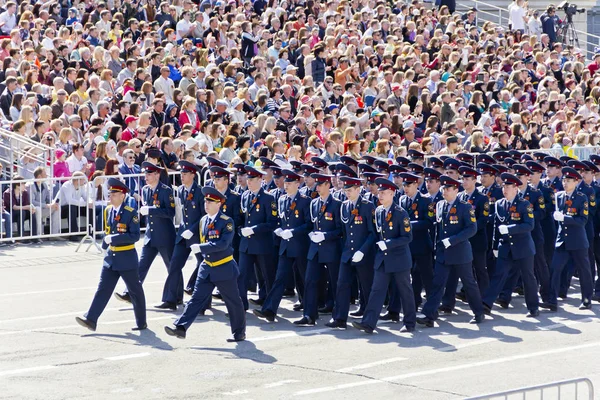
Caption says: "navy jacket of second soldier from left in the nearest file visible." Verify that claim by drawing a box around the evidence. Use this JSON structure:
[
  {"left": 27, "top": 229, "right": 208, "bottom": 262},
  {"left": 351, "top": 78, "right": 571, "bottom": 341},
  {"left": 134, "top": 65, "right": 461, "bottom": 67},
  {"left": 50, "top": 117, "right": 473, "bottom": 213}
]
[{"left": 436, "top": 199, "right": 477, "bottom": 264}]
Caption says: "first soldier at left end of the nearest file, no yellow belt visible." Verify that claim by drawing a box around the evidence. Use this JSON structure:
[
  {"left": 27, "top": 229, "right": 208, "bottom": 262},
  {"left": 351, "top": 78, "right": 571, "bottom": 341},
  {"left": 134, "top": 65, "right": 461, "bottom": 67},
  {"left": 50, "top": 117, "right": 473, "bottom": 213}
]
[{"left": 352, "top": 178, "right": 416, "bottom": 333}]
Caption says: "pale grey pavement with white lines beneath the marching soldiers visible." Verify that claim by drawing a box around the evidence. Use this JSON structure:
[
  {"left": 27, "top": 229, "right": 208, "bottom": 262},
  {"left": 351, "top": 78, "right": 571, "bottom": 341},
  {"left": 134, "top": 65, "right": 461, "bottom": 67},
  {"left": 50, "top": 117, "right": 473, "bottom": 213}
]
[{"left": 0, "top": 242, "right": 600, "bottom": 400}]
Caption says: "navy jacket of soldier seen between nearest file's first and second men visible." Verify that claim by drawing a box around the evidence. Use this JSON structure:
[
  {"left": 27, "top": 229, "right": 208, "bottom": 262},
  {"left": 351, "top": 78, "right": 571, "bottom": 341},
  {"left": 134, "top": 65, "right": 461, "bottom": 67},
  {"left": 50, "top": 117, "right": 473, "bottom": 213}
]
[{"left": 400, "top": 192, "right": 435, "bottom": 256}]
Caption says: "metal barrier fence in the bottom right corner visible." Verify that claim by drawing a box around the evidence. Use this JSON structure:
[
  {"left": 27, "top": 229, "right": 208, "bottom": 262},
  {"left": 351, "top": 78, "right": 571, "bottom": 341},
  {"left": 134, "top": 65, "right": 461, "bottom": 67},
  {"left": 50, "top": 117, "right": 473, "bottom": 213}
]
[{"left": 466, "top": 378, "right": 594, "bottom": 400}]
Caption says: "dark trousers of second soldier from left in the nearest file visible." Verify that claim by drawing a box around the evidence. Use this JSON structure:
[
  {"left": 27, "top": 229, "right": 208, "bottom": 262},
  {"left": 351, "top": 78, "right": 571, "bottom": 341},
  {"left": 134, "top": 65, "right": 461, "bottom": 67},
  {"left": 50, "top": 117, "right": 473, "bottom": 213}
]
[{"left": 422, "top": 262, "right": 483, "bottom": 320}]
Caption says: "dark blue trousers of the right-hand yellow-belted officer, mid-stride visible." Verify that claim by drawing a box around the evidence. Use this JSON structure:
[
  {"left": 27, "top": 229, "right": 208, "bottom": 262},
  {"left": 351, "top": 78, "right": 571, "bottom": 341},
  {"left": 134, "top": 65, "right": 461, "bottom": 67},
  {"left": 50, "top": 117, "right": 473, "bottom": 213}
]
[{"left": 174, "top": 270, "right": 246, "bottom": 335}]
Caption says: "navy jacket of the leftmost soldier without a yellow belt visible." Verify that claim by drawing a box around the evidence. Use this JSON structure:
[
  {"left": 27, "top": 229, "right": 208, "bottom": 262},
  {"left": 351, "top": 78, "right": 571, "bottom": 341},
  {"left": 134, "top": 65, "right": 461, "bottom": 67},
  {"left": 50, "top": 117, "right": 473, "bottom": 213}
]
[{"left": 142, "top": 182, "right": 175, "bottom": 247}]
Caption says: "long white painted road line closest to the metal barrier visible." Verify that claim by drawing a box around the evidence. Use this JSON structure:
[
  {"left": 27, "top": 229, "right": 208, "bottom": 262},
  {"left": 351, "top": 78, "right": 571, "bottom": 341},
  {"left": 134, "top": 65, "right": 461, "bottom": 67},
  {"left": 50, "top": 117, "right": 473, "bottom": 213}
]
[{"left": 294, "top": 342, "right": 600, "bottom": 396}]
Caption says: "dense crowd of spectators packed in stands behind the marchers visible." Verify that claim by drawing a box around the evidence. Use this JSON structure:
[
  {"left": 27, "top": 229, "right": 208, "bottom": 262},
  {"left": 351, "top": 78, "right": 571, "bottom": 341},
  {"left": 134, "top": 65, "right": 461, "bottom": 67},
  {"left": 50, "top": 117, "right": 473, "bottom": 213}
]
[{"left": 0, "top": 0, "right": 600, "bottom": 241}]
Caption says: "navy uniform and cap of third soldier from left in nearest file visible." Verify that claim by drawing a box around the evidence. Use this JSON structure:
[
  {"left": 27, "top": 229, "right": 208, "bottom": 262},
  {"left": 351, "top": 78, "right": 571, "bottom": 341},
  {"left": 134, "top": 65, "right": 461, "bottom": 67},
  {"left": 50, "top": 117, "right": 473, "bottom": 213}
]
[{"left": 483, "top": 173, "right": 539, "bottom": 316}]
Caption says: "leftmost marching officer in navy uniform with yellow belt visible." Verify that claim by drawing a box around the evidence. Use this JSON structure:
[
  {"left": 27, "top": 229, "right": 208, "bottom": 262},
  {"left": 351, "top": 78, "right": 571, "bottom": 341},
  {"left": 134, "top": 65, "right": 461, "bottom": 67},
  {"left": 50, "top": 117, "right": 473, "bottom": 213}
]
[{"left": 75, "top": 178, "right": 148, "bottom": 331}]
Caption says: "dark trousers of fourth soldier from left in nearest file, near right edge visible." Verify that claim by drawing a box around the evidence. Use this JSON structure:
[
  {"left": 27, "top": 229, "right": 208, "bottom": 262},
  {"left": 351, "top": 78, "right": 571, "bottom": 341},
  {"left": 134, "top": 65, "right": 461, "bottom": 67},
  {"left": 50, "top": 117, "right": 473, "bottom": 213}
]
[{"left": 548, "top": 244, "right": 594, "bottom": 305}]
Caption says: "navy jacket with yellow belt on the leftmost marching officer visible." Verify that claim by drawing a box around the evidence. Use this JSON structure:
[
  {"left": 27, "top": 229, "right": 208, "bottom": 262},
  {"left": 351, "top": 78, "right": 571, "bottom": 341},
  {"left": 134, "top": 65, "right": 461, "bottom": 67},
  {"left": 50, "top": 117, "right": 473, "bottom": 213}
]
[{"left": 102, "top": 202, "right": 140, "bottom": 271}]
